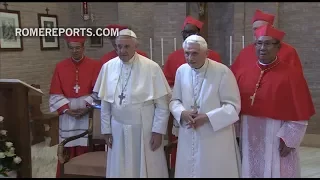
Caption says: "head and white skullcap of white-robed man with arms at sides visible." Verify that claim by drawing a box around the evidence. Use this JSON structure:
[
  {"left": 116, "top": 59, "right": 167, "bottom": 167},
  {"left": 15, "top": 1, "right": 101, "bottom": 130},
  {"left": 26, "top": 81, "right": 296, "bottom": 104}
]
[{"left": 116, "top": 29, "right": 138, "bottom": 62}]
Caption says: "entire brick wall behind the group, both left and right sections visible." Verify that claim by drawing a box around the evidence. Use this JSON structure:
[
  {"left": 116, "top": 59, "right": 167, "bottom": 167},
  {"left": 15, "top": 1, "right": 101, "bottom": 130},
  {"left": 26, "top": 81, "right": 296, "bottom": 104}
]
[{"left": 0, "top": 2, "right": 320, "bottom": 133}]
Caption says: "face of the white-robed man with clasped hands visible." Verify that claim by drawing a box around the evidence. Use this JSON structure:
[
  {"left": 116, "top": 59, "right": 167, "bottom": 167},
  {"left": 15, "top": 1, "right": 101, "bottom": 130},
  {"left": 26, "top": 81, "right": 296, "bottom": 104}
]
[{"left": 184, "top": 43, "right": 207, "bottom": 68}]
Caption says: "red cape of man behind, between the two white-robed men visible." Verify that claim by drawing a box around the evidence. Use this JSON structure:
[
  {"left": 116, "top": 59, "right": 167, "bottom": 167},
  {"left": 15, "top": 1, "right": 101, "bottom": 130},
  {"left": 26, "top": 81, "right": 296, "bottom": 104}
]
[{"left": 163, "top": 48, "right": 221, "bottom": 86}]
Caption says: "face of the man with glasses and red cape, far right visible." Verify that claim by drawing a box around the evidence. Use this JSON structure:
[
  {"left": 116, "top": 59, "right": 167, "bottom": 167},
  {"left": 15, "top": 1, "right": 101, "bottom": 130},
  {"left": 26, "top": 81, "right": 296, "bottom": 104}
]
[{"left": 255, "top": 36, "right": 280, "bottom": 64}]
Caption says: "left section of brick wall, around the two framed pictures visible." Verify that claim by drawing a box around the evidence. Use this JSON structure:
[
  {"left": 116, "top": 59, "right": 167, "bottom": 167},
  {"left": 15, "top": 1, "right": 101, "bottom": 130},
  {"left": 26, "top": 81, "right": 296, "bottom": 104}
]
[{"left": 0, "top": 2, "right": 186, "bottom": 112}]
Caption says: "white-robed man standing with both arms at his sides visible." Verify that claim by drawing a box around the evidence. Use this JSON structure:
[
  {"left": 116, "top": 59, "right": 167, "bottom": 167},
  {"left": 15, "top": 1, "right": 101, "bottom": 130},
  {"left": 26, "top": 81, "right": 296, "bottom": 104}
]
[{"left": 94, "top": 29, "right": 171, "bottom": 178}]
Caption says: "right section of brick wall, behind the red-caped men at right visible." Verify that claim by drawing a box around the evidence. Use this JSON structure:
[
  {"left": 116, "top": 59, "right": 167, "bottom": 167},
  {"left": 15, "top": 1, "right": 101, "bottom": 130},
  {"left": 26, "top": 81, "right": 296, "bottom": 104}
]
[{"left": 225, "top": 2, "right": 320, "bottom": 134}]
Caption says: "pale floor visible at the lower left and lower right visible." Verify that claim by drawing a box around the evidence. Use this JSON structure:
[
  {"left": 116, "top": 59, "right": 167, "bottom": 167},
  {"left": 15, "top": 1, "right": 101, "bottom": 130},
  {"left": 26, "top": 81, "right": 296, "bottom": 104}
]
[{"left": 32, "top": 143, "right": 320, "bottom": 178}]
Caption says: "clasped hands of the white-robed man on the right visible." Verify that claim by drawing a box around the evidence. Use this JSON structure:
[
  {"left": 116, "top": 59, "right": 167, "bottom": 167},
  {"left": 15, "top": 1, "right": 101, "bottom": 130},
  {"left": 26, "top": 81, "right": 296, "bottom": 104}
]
[{"left": 181, "top": 111, "right": 209, "bottom": 129}]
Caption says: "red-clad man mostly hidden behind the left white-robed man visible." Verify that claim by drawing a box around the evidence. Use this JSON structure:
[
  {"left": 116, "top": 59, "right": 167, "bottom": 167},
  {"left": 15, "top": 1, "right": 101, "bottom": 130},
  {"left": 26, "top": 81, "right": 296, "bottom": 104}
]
[{"left": 100, "top": 24, "right": 148, "bottom": 67}]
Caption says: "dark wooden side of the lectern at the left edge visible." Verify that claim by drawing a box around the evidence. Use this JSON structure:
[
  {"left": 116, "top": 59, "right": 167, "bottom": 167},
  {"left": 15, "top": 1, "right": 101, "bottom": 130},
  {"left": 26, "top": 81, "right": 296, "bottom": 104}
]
[{"left": 0, "top": 83, "right": 32, "bottom": 178}]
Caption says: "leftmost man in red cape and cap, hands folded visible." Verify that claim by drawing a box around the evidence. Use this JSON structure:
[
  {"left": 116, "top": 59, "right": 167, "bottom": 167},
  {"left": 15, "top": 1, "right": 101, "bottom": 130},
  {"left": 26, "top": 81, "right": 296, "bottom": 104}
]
[{"left": 49, "top": 36, "right": 105, "bottom": 177}]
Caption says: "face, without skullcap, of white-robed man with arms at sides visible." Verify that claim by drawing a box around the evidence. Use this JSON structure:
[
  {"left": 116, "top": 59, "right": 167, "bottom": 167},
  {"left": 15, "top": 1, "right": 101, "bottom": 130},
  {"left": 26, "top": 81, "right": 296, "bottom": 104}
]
[{"left": 116, "top": 36, "right": 137, "bottom": 62}]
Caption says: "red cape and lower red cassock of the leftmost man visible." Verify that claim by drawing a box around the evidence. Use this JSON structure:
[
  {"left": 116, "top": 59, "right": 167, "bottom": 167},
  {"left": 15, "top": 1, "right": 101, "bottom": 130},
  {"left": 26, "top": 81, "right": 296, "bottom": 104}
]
[{"left": 50, "top": 57, "right": 105, "bottom": 177}]
